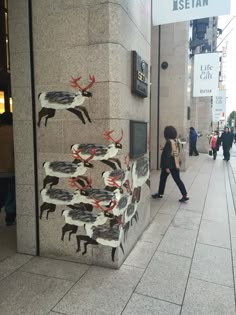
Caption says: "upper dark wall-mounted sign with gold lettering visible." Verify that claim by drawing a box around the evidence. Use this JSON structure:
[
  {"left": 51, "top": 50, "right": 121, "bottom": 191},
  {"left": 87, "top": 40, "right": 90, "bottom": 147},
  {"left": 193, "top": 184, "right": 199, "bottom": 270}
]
[{"left": 132, "top": 51, "right": 148, "bottom": 97}]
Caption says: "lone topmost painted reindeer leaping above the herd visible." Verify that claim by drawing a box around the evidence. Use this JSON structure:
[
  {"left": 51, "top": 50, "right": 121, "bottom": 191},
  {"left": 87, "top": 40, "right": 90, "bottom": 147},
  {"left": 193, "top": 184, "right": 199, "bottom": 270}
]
[{"left": 38, "top": 75, "right": 95, "bottom": 127}]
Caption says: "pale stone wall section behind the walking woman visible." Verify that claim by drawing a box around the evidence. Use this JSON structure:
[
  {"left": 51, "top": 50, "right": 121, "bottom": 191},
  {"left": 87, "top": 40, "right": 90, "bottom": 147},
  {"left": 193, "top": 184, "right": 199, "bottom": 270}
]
[{"left": 151, "top": 23, "right": 191, "bottom": 169}]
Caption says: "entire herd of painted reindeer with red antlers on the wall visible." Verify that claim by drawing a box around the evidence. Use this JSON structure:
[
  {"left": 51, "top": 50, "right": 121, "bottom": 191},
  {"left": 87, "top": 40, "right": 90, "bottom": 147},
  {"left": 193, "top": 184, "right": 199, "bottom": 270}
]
[{"left": 38, "top": 76, "right": 149, "bottom": 262}]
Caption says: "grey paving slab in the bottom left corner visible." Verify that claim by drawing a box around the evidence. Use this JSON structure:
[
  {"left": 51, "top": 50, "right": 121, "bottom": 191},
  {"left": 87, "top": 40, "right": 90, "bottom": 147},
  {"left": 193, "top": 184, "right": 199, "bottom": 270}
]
[{"left": 0, "top": 272, "right": 74, "bottom": 315}]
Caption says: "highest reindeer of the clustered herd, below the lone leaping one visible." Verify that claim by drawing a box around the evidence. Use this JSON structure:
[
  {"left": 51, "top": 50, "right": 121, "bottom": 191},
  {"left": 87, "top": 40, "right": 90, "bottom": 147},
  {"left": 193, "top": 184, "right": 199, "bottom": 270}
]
[{"left": 71, "top": 129, "right": 123, "bottom": 169}]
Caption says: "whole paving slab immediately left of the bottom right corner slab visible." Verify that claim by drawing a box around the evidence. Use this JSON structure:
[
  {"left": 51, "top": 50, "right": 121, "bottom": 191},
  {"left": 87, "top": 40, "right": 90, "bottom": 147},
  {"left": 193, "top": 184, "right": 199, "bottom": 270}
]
[{"left": 136, "top": 251, "right": 191, "bottom": 305}]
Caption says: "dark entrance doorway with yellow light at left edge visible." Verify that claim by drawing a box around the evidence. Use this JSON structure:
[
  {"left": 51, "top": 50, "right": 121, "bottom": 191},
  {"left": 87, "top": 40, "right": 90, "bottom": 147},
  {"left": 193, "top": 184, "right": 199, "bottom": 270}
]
[{"left": 0, "top": 0, "right": 16, "bottom": 261}]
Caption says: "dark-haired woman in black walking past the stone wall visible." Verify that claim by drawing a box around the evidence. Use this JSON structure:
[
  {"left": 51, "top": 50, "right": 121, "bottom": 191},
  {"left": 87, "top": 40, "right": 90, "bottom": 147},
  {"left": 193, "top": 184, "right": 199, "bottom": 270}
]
[{"left": 152, "top": 126, "right": 189, "bottom": 202}]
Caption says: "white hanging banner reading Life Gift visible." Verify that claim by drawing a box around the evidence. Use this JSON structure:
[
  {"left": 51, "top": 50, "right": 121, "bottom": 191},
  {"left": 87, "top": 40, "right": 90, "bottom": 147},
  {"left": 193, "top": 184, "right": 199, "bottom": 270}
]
[{"left": 193, "top": 53, "right": 220, "bottom": 97}]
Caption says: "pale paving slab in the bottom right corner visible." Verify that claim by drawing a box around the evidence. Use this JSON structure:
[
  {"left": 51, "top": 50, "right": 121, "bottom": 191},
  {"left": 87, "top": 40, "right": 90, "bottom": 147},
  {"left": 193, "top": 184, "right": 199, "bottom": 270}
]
[{"left": 181, "top": 278, "right": 235, "bottom": 315}]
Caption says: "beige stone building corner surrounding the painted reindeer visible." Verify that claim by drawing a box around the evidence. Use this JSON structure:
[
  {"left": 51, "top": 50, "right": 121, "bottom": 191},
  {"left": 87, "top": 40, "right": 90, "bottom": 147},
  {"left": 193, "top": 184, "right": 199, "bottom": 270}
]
[{"left": 10, "top": 0, "right": 151, "bottom": 268}]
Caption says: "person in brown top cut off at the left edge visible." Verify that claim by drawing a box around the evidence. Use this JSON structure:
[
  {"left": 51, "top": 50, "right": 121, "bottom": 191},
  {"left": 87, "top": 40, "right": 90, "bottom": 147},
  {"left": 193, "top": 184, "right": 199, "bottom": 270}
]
[{"left": 0, "top": 112, "right": 16, "bottom": 225}]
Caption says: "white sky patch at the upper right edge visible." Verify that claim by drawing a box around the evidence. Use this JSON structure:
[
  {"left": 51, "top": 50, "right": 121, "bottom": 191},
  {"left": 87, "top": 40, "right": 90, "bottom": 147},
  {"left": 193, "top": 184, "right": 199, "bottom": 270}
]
[{"left": 217, "top": 0, "right": 236, "bottom": 116}]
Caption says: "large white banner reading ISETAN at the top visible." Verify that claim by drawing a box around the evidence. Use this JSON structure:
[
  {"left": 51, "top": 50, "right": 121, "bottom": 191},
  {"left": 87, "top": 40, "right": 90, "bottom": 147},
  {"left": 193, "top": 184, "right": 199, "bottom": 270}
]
[{"left": 152, "top": 0, "right": 230, "bottom": 25}]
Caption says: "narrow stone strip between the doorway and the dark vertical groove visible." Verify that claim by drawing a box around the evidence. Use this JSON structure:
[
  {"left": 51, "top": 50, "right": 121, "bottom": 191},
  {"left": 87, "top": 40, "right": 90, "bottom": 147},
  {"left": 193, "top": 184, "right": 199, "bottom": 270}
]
[{"left": 8, "top": 0, "right": 36, "bottom": 255}]
